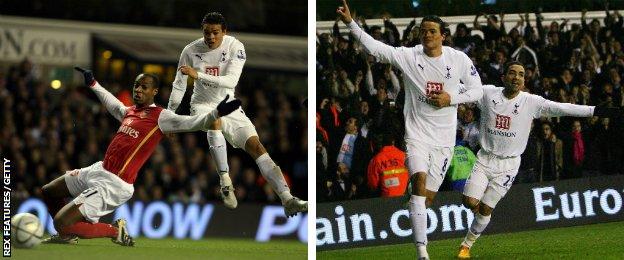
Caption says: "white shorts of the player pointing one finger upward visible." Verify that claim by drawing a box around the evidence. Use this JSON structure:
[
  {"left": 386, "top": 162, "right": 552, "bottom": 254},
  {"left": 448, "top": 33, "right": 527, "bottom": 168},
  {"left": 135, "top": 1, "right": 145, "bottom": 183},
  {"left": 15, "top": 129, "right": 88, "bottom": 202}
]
[{"left": 405, "top": 140, "right": 453, "bottom": 192}]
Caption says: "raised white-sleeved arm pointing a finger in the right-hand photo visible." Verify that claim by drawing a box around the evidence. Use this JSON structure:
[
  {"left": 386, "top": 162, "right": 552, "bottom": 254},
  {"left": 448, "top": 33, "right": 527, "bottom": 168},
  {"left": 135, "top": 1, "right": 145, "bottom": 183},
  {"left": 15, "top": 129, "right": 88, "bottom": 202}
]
[{"left": 336, "top": 0, "right": 405, "bottom": 67}]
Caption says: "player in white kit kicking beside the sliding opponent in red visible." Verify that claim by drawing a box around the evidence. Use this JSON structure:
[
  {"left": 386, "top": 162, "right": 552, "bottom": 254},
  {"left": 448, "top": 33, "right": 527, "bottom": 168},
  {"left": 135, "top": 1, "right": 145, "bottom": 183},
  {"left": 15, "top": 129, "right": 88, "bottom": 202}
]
[{"left": 168, "top": 12, "right": 308, "bottom": 216}]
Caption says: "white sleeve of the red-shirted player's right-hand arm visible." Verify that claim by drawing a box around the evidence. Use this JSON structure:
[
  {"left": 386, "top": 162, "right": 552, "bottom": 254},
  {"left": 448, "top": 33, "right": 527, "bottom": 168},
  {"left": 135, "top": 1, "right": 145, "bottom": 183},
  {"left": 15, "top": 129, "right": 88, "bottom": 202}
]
[{"left": 158, "top": 109, "right": 218, "bottom": 133}]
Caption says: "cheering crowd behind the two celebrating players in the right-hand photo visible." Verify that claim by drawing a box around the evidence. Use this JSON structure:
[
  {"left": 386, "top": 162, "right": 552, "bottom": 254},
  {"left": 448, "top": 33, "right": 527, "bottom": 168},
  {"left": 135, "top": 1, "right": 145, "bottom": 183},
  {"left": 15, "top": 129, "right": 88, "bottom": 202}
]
[{"left": 316, "top": 10, "right": 624, "bottom": 201}]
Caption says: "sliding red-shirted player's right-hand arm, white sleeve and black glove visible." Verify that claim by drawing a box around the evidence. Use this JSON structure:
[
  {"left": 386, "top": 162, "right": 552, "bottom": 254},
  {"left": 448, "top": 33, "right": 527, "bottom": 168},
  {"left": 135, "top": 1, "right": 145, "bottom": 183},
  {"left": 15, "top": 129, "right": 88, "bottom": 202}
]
[{"left": 158, "top": 95, "right": 241, "bottom": 134}]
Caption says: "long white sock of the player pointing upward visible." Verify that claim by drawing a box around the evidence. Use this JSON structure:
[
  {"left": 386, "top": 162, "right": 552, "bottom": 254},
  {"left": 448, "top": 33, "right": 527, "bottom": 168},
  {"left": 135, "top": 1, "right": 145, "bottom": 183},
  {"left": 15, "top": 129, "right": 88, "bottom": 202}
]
[{"left": 409, "top": 195, "right": 429, "bottom": 259}]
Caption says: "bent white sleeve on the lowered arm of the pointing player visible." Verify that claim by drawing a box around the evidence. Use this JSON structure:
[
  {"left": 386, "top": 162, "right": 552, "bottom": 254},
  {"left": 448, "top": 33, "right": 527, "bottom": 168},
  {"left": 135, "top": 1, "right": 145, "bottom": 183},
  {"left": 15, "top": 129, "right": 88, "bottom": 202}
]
[{"left": 450, "top": 52, "right": 483, "bottom": 105}]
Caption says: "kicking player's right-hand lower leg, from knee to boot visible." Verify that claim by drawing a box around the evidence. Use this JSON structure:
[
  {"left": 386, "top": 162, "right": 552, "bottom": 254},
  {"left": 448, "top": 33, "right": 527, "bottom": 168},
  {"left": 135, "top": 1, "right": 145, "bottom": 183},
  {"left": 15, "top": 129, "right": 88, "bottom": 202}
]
[{"left": 245, "top": 135, "right": 308, "bottom": 216}]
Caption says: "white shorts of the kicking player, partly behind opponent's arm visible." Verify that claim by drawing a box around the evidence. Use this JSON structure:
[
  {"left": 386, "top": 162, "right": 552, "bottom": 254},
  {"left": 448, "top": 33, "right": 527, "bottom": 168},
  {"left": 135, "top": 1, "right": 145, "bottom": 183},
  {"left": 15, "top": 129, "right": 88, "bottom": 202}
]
[{"left": 191, "top": 104, "right": 258, "bottom": 149}]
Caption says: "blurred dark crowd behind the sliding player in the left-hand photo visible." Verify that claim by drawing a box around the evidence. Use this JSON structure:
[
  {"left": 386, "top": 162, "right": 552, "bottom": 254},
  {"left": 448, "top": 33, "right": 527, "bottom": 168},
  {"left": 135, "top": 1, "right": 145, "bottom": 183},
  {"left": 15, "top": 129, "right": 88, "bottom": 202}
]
[{"left": 0, "top": 60, "right": 308, "bottom": 203}]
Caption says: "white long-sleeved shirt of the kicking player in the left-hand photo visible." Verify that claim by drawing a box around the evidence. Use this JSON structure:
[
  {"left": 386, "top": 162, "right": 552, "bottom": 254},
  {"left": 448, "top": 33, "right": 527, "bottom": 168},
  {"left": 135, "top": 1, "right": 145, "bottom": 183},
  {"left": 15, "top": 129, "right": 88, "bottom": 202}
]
[{"left": 168, "top": 35, "right": 247, "bottom": 111}]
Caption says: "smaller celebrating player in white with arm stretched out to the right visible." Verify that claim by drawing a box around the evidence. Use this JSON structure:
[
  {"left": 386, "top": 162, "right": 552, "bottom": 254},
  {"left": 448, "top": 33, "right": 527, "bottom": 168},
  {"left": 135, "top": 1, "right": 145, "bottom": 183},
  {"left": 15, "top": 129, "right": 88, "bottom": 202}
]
[{"left": 458, "top": 62, "right": 621, "bottom": 258}]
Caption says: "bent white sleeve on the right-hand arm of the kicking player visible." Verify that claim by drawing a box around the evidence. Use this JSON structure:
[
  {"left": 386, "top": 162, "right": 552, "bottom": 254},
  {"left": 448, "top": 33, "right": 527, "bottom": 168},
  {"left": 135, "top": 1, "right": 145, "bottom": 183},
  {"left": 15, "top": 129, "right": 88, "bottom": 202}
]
[{"left": 197, "top": 41, "right": 247, "bottom": 89}]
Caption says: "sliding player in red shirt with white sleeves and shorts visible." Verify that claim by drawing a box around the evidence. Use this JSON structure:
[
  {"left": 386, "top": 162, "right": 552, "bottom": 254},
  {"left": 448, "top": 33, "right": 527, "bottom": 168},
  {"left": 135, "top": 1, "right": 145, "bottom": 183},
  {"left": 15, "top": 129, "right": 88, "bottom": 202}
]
[{"left": 42, "top": 67, "right": 241, "bottom": 246}]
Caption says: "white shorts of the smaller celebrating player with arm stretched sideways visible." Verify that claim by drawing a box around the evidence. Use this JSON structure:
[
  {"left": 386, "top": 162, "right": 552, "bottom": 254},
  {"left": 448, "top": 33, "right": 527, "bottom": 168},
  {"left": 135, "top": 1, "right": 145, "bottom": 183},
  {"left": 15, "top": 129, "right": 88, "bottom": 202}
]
[{"left": 464, "top": 149, "right": 520, "bottom": 208}]
